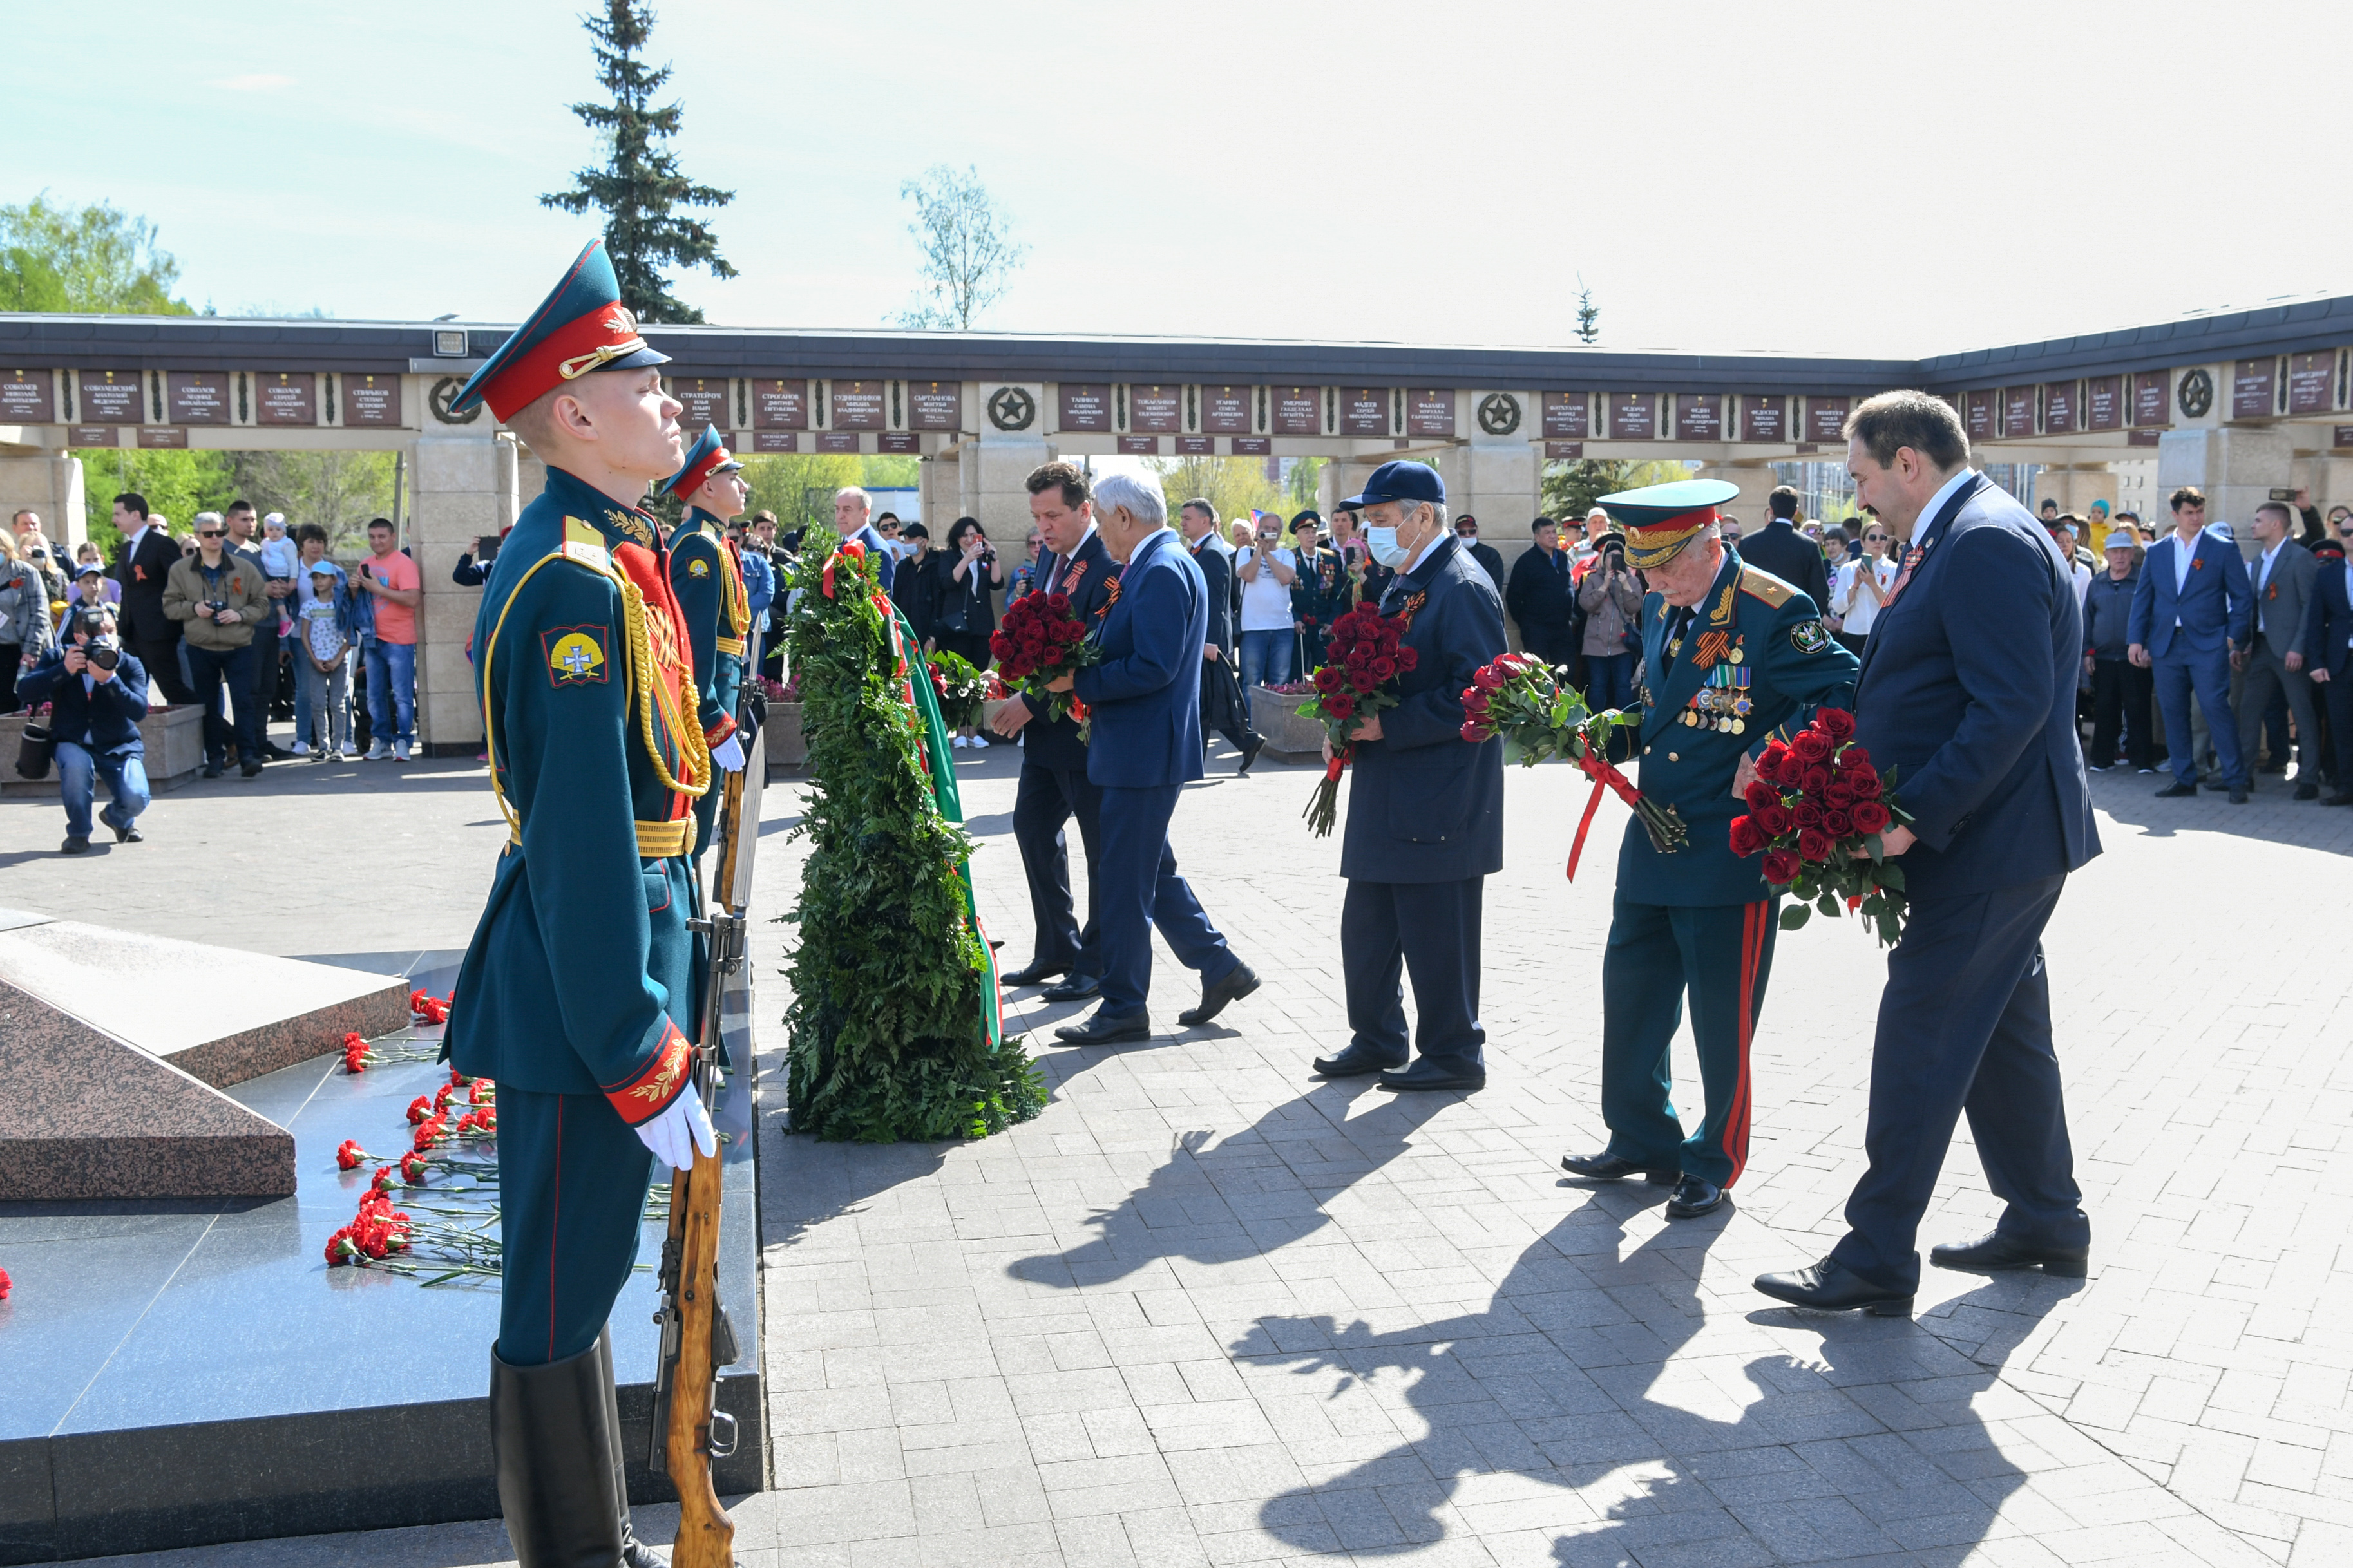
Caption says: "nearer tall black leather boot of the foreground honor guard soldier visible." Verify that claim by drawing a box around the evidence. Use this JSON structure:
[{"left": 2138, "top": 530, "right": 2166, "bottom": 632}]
[{"left": 490, "top": 1345, "right": 626, "bottom": 1568}]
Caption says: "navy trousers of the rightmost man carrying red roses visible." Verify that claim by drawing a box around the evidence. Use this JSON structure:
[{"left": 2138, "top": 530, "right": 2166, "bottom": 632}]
[{"left": 1831, "top": 874, "right": 2092, "bottom": 1290}]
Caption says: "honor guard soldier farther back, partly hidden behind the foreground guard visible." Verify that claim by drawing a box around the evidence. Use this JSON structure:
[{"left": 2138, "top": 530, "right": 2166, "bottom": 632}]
[{"left": 661, "top": 426, "right": 750, "bottom": 860}]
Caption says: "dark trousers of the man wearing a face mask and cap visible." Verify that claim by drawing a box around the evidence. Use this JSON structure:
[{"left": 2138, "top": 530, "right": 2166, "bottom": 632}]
[{"left": 1339, "top": 877, "right": 1487, "bottom": 1070}]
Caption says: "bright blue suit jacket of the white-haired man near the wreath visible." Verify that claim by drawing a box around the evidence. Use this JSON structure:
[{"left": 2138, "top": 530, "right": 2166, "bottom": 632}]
[{"left": 1078, "top": 529, "right": 1210, "bottom": 790}]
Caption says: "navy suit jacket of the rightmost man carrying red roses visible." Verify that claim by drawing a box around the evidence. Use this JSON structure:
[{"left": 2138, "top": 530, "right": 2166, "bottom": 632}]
[{"left": 1854, "top": 477, "right": 2099, "bottom": 898}]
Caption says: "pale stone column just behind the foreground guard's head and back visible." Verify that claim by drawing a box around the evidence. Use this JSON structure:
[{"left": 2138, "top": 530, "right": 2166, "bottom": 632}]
[{"left": 403, "top": 420, "right": 520, "bottom": 755}]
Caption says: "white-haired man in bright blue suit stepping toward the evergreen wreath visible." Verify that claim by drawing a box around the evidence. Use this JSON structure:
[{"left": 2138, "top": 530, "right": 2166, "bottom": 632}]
[{"left": 1054, "top": 475, "right": 1259, "bottom": 1046}]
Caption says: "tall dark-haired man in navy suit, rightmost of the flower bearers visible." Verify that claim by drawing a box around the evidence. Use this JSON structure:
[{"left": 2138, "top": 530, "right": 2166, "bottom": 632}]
[{"left": 1755, "top": 393, "right": 2108, "bottom": 1314}]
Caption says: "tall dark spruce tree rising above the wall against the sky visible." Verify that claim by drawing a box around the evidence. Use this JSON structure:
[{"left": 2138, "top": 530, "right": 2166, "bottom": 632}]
[{"left": 539, "top": 0, "right": 736, "bottom": 322}]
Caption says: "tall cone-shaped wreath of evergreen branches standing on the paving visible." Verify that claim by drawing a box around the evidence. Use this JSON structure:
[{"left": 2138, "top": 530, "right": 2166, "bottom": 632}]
[{"left": 783, "top": 540, "right": 1045, "bottom": 1142}]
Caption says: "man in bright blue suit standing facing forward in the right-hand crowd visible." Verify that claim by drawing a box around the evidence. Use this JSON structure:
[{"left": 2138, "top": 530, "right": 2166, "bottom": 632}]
[{"left": 2125, "top": 484, "right": 2254, "bottom": 806}]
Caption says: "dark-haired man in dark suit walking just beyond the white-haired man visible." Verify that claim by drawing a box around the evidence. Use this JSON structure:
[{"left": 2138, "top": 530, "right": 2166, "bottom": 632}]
[{"left": 995, "top": 461, "right": 1120, "bottom": 1001}]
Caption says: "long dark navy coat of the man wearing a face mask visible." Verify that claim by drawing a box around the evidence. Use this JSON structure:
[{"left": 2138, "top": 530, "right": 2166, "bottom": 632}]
[{"left": 1339, "top": 538, "right": 1510, "bottom": 882}]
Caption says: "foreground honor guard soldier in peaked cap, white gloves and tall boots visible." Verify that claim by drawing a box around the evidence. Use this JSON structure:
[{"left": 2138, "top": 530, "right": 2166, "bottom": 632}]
[{"left": 447, "top": 240, "right": 718, "bottom": 1568}]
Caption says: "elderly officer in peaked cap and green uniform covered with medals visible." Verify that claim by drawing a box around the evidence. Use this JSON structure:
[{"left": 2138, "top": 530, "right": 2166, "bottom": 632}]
[{"left": 1560, "top": 480, "right": 1856, "bottom": 1220}]
